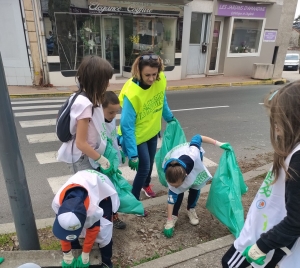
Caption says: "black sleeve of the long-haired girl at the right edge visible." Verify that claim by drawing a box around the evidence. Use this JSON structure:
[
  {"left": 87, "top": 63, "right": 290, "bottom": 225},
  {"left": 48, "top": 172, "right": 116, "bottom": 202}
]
[{"left": 256, "top": 152, "right": 300, "bottom": 253}]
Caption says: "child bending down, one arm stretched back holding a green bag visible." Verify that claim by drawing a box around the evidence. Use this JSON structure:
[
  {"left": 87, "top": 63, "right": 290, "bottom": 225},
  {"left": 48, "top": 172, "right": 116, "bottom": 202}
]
[{"left": 163, "top": 134, "right": 224, "bottom": 237}]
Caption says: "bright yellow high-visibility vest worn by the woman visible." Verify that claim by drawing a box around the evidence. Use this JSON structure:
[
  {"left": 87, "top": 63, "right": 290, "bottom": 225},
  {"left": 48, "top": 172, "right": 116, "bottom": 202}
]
[{"left": 118, "top": 72, "right": 167, "bottom": 145}]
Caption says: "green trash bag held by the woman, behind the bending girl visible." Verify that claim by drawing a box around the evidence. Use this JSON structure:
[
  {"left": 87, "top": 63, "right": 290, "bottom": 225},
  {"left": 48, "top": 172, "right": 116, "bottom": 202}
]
[{"left": 155, "top": 119, "right": 186, "bottom": 187}]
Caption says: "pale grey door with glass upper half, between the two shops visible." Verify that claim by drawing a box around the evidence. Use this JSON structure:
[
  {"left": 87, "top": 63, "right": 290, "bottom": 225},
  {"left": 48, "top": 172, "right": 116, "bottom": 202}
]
[{"left": 187, "top": 12, "right": 210, "bottom": 75}]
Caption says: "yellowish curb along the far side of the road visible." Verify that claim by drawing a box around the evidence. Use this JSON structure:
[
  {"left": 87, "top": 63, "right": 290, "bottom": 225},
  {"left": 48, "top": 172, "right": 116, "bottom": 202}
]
[{"left": 9, "top": 78, "right": 287, "bottom": 99}]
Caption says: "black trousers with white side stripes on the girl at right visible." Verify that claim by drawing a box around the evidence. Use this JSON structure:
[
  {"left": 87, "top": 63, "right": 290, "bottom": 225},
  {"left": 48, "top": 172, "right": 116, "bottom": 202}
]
[{"left": 222, "top": 240, "right": 296, "bottom": 268}]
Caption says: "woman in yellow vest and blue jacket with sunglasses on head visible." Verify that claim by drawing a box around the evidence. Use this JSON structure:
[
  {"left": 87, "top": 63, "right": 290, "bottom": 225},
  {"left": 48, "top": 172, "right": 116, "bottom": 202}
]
[{"left": 118, "top": 52, "right": 174, "bottom": 204}]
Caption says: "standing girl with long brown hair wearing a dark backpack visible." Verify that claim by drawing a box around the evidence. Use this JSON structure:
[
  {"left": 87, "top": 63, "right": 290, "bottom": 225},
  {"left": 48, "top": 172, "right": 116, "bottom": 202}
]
[{"left": 57, "top": 56, "right": 113, "bottom": 174}]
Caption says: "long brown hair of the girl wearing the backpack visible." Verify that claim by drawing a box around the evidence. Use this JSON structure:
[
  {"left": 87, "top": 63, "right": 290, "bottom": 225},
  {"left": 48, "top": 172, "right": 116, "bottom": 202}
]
[{"left": 76, "top": 55, "right": 113, "bottom": 106}]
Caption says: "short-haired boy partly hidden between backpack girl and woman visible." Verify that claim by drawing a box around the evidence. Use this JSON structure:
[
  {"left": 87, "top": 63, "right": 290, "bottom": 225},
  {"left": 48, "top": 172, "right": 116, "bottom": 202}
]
[{"left": 102, "top": 91, "right": 126, "bottom": 229}]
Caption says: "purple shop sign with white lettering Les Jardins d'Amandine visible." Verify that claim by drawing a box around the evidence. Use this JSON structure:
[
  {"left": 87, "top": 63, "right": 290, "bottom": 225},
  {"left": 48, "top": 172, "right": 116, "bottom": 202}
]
[{"left": 218, "top": 2, "right": 267, "bottom": 18}]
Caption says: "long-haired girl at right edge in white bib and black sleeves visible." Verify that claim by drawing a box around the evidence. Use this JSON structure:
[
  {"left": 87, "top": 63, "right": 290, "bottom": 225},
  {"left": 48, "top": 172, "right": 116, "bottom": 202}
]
[{"left": 222, "top": 81, "right": 300, "bottom": 268}]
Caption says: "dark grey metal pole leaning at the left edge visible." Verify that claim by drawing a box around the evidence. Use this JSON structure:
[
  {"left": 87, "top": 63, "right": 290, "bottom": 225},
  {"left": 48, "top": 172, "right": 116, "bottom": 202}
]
[{"left": 0, "top": 53, "right": 40, "bottom": 250}]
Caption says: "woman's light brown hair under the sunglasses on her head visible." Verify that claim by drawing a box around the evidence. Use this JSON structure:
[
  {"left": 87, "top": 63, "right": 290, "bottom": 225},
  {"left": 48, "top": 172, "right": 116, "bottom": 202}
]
[{"left": 131, "top": 51, "right": 165, "bottom": 81}]
